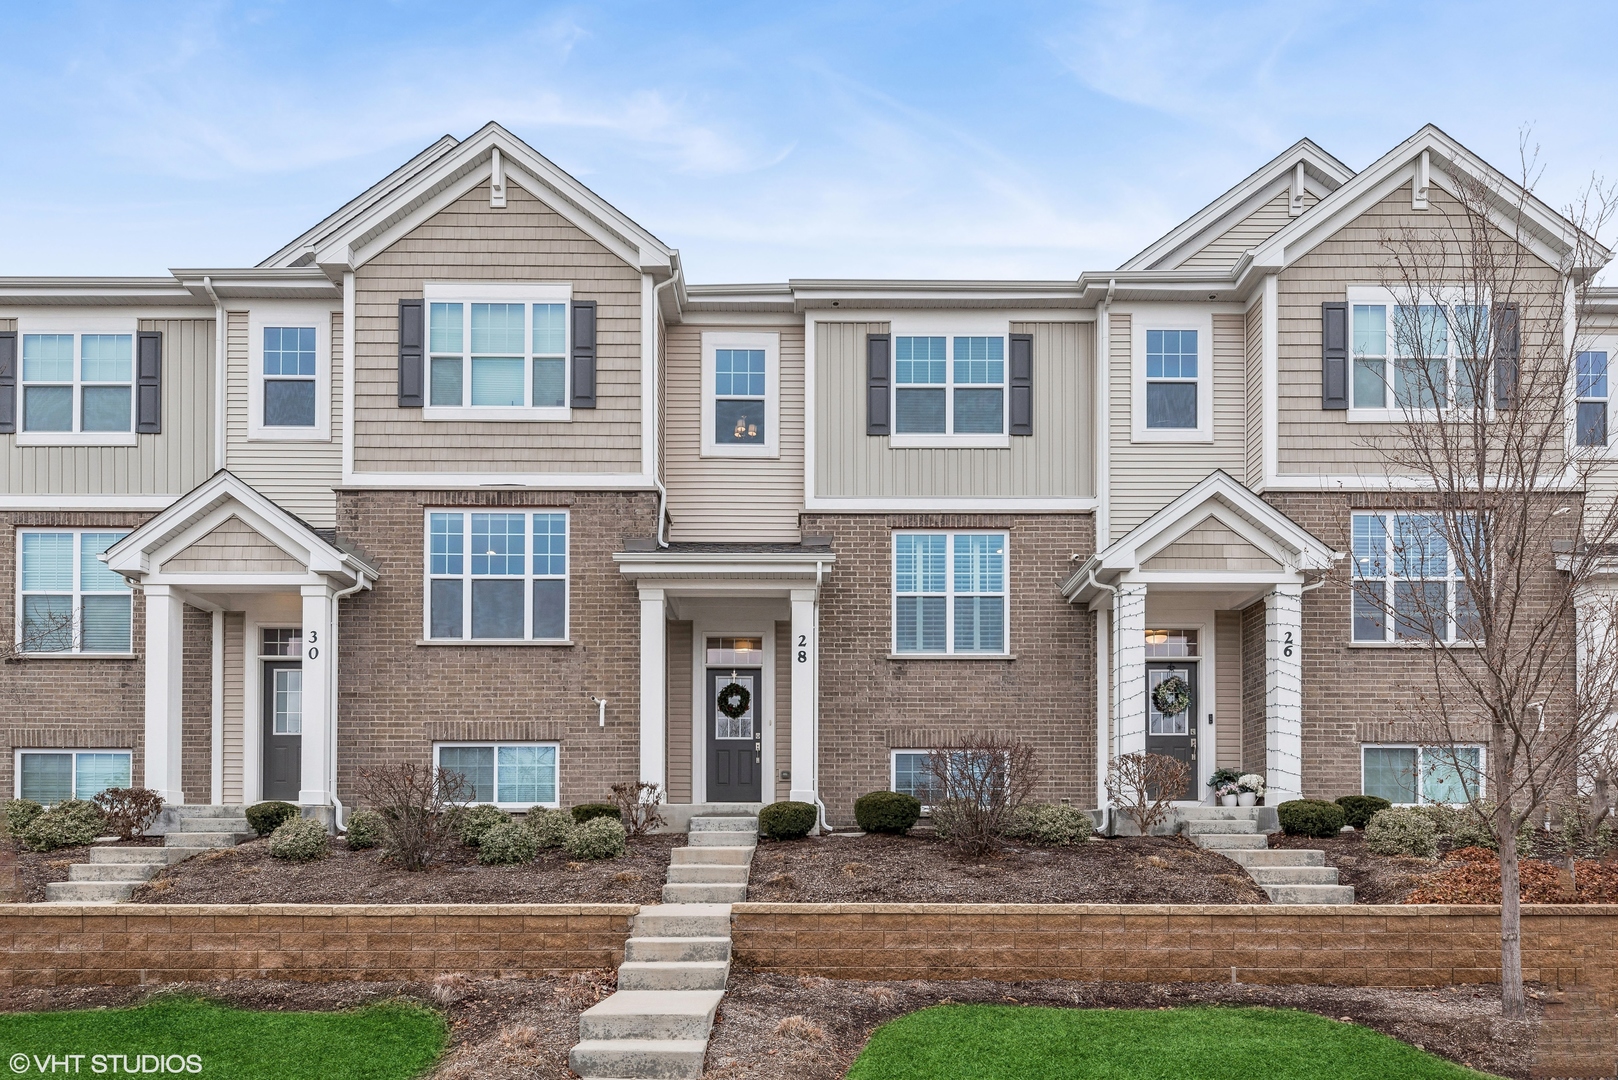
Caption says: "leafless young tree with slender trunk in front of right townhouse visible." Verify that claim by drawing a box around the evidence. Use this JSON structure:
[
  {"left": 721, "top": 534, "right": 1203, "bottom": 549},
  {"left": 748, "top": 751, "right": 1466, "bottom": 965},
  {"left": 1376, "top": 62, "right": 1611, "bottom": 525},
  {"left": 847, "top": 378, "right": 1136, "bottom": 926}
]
[{"left": 1343, "top": 131, "right": 1618, "bottom": 1017}]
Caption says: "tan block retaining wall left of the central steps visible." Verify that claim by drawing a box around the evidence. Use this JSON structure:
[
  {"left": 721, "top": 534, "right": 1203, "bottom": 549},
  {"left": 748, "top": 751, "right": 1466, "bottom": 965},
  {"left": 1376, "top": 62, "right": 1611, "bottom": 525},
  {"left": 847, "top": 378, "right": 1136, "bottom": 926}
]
[{"left": 0, "top": 904, "right": 637, "bottom": 989}]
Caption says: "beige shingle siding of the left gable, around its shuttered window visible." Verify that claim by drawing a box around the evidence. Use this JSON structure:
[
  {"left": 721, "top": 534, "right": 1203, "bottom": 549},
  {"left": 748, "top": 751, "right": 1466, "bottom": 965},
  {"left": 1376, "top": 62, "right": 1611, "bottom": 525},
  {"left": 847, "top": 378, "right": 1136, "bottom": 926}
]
[{"left": 354, "top": 183, "right": 641, "bottom": 474}]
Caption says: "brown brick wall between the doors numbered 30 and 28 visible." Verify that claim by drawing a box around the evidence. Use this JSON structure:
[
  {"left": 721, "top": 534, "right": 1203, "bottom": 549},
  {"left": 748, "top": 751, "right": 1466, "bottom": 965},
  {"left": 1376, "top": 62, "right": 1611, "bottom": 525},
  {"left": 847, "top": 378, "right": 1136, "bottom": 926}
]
[{"left": 337, "top": 491, "right": 657, "bottom": 805}]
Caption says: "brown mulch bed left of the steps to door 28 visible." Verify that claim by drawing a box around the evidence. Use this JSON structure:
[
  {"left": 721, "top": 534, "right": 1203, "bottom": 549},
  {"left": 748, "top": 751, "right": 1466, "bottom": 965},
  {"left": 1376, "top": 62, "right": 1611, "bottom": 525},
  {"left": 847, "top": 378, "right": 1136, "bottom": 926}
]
[{"left": 131, "top": 834, "right": 686, "bottom": 904}]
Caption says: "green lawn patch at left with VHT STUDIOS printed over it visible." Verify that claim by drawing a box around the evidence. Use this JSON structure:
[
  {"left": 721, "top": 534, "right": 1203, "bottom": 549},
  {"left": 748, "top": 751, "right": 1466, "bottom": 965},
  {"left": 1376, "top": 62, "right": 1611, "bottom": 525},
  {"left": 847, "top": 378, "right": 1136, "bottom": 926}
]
[{"left": 0, "top": 997, "right": 447, "bottom": 1080}]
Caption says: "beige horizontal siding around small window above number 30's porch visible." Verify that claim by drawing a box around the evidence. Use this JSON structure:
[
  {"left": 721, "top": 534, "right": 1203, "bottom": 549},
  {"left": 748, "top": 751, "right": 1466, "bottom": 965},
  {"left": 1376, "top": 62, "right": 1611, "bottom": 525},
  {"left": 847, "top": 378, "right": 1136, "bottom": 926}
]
[{"left": 225, "top": 309, "right": 345, "bottom": 528}]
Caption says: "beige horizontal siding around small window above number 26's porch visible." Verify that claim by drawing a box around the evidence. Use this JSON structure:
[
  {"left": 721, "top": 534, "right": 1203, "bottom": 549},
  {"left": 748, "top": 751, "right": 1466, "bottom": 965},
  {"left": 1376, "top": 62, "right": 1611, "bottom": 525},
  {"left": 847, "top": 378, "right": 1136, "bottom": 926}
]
[{"left": 1108, "top": 313, "right": 1247, "bottom": 539}]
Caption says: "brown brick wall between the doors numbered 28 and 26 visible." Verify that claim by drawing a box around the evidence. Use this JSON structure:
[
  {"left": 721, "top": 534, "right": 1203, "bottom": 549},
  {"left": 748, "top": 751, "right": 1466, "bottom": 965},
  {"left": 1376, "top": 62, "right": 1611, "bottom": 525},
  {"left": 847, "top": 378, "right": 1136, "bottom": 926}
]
[{"left": 803, "top": 513, "right": 1095, "bottom": 824}]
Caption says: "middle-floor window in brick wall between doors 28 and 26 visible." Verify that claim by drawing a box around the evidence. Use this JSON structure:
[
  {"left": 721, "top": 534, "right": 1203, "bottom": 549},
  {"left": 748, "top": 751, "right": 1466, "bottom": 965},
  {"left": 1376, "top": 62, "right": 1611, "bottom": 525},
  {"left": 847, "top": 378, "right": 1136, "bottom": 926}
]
[{"left": 893, "top": 533, "right": 1006, "bottom": 656}]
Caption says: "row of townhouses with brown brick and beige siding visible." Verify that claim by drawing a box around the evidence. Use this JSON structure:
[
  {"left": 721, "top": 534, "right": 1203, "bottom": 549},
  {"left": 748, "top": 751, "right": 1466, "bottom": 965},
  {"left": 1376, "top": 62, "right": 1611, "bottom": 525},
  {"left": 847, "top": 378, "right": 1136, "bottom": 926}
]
[{"left": 0, "top": 125, "right": 1618, "bottom": 824}]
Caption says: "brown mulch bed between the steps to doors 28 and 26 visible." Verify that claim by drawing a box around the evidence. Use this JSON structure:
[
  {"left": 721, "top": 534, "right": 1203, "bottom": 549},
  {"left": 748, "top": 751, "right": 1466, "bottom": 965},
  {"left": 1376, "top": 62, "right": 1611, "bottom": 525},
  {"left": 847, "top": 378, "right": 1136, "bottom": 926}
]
[{"left": 748, "top": 834, "right": 1269, "bottom": 904}]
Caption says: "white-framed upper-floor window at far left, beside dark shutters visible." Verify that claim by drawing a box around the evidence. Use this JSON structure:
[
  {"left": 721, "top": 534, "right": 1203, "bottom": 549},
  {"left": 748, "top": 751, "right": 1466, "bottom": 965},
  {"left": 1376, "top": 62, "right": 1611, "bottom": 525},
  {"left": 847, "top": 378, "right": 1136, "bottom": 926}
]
[{"left": 23, "top": 334, "right": 134, "bottom": 436}]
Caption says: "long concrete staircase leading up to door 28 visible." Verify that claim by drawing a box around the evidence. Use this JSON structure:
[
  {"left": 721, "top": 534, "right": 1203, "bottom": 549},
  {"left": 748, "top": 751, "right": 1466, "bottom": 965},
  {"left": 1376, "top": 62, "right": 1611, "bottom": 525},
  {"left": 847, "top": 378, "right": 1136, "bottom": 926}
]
[{"left": 568, "top": 814, "right": 759, "bottom": 1080}]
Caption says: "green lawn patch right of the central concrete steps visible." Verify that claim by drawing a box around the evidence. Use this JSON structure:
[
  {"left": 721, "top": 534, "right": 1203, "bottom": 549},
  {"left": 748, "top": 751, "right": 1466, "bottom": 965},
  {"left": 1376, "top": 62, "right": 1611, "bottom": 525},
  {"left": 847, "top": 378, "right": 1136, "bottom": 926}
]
[{"left": 848, "top": 1006, "right": 1487, "bottom": 1080}]
